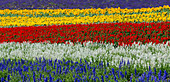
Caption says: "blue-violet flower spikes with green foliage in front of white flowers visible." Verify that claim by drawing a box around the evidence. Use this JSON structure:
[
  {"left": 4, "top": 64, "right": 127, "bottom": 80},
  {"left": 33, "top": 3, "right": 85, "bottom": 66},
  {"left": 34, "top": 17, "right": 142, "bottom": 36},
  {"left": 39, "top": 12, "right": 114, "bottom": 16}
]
[{"left": 0, "top": 58, "right": 170, "bottom": 82}]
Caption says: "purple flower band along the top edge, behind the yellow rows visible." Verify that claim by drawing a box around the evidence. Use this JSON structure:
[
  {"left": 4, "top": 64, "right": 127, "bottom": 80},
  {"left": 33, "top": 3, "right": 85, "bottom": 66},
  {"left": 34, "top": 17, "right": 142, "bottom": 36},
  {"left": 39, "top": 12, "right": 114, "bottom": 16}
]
[{"left": 0, "top": 0, "right": 170, "bottom": 9}]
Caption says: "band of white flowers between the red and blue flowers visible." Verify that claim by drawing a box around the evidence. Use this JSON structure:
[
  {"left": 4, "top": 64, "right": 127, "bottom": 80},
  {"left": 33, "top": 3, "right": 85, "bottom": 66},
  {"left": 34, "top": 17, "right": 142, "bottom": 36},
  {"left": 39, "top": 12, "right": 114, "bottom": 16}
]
[{"left": 0, "top": 41, "right": 170, "bottom": 66}]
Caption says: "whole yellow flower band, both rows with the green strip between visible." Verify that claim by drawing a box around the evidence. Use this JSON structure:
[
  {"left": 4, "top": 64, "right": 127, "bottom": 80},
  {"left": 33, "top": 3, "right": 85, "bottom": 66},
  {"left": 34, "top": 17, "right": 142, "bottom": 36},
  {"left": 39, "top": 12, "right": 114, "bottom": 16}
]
[{"left": 0, "top": 6, "right": 170, "bottom": 27}]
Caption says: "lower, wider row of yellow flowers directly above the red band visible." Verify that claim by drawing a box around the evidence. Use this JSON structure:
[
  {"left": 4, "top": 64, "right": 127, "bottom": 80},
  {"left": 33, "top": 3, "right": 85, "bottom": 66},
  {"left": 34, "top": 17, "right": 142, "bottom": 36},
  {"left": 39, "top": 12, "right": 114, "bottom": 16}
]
[{"left": 0, "top": 12, "right": 170, "bottom": 27}]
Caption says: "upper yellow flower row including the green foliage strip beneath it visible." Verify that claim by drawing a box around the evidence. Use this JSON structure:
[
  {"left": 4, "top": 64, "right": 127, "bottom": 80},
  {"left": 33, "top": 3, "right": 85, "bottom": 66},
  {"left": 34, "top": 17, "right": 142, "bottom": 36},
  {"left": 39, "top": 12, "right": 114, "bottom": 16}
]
[{"left": 0, "top": 5, "right": 170, "bottom": 17}]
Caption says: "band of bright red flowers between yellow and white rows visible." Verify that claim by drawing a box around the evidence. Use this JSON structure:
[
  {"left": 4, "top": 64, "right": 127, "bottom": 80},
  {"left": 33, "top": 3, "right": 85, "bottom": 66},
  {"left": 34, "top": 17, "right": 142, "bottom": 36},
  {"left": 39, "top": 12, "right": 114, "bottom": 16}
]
[{"left": 0, "top": 22, "right": 170, "bottom": 45}]
